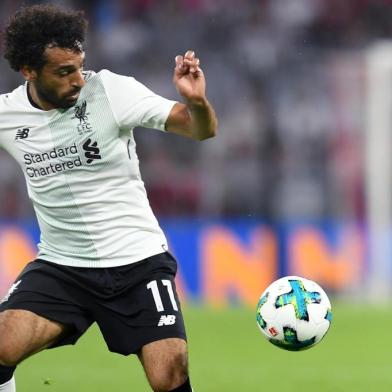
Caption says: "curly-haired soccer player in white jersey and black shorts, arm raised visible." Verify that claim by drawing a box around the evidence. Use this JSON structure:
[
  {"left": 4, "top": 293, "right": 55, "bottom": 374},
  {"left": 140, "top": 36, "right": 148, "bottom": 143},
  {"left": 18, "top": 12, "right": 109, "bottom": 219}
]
[{"left": 0, "top": 5, "right": 217, "bottom": 392}]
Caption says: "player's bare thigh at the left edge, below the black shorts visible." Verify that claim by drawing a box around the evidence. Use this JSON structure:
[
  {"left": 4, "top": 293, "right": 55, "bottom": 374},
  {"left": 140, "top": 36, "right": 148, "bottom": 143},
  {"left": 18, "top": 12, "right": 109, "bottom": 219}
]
[{"left": 0, "top": 310, "right": 67, "bottom": 366}]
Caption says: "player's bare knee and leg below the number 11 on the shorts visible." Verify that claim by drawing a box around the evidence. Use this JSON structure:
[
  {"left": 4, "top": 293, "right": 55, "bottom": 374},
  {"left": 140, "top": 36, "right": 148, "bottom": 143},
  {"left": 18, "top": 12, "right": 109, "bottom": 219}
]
[{"left": 139, "top": 338, "right": 188, "bottom": 392}]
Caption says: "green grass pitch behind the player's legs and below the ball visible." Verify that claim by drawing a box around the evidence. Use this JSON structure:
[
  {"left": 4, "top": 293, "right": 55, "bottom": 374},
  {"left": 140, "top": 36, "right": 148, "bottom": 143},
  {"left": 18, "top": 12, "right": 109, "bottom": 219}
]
[{"left": 16, "top": 304, "right": 392, "bottom": 392}]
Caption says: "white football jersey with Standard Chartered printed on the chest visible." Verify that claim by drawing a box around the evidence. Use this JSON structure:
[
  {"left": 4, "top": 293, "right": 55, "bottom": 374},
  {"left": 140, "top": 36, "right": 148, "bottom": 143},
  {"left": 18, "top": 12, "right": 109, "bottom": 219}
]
[{"left": 0, "top": 70, "right": 175, "bottom": 267}]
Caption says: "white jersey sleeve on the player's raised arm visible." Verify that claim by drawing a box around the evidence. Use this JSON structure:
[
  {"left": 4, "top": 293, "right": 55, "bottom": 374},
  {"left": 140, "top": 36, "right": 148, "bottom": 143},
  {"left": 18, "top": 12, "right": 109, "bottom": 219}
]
[{"left": 99, "top": 70, "right": 176, "bottom": 131}]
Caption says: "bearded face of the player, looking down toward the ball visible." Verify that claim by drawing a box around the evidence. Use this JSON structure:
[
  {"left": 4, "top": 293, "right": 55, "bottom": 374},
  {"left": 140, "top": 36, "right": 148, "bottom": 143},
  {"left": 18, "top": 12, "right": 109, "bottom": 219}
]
[{"left": 32, "top": 47, "right": 85, "bottom": 110}]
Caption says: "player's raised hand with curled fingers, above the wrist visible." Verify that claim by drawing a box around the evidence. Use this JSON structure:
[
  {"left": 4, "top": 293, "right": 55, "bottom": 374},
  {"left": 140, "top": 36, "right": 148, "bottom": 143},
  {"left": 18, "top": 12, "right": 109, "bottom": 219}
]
[{"left": 173, "top": 50, "right": 206, "bottom": 105}]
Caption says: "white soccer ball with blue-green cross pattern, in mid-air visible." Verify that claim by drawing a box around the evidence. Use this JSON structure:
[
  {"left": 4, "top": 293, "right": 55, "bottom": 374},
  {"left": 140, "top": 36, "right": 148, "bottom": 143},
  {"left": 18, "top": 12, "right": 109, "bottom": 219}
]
[{"left": 256, "top": 276, "right": 332, "bottom": 351}]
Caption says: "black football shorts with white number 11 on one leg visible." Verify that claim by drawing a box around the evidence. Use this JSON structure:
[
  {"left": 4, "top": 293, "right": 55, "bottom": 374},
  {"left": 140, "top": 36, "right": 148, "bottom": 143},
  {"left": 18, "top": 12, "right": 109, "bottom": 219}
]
[{"left": 0, "top": 252, "right": 186, "bottom": 355}]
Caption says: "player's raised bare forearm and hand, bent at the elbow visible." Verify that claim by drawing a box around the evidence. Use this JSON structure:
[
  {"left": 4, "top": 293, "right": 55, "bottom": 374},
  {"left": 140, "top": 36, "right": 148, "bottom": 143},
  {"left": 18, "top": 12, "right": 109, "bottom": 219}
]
[{"left": 166, "top": 50, "right": 218, "bottom": 140}]
